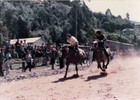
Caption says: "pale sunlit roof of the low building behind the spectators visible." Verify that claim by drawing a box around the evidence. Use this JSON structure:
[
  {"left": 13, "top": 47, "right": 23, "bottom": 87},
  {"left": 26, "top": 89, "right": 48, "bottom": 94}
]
[{"left": 10, "top": 37, "right": 41, "bottom": 44}]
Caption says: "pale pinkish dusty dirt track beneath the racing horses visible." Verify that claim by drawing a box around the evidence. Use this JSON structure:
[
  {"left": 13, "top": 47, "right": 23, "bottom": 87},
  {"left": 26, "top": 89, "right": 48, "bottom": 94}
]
[{"left": 0, "top": 57, "right": 140, "bottom": 100}]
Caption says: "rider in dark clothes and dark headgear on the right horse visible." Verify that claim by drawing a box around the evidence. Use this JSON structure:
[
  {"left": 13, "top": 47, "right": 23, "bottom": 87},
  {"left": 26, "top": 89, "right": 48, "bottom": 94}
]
[{"left": 92, "top": 31, "right": 109, "bottom": 61}]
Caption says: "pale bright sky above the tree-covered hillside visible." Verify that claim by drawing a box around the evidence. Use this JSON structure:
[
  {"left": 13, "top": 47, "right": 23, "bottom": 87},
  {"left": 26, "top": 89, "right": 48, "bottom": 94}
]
[{"left": 84, "top": 0, "right": 140, "bottom": 22}]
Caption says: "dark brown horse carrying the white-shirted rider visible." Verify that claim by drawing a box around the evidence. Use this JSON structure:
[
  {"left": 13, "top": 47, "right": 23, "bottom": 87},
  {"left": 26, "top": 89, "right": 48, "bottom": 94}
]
[{"left": 62, "top": 46, "right": 86, "bottom": 78}]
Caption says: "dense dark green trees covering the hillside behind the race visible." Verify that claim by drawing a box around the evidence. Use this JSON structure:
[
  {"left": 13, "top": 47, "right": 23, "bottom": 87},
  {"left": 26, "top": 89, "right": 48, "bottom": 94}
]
[{"left": 0, "top": 1, "right": 136, "bottom": 44}]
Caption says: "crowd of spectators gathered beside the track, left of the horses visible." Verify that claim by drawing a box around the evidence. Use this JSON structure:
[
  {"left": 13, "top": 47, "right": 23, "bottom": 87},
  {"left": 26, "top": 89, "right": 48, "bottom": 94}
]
[{"left": 0, "top": 39, "right": 61, "bottom": 76}]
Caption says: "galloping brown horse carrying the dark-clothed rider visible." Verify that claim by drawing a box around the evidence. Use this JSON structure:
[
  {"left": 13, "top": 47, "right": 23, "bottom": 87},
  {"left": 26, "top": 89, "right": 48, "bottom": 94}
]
[{"left": 93, "top": 41, "right": 110, "bottom": 72}]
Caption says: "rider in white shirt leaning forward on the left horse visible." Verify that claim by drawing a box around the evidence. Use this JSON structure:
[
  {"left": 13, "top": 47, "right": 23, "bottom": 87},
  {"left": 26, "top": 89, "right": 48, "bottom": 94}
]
[{"left": 67, "top": 34, "right": 79, "bottom": 52}]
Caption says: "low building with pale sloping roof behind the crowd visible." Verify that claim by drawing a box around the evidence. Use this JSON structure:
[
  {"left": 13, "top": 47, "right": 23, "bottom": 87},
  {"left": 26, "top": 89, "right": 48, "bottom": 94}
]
[{"left": 10, "top": 37, "right": 46, "bottom": 47}]
